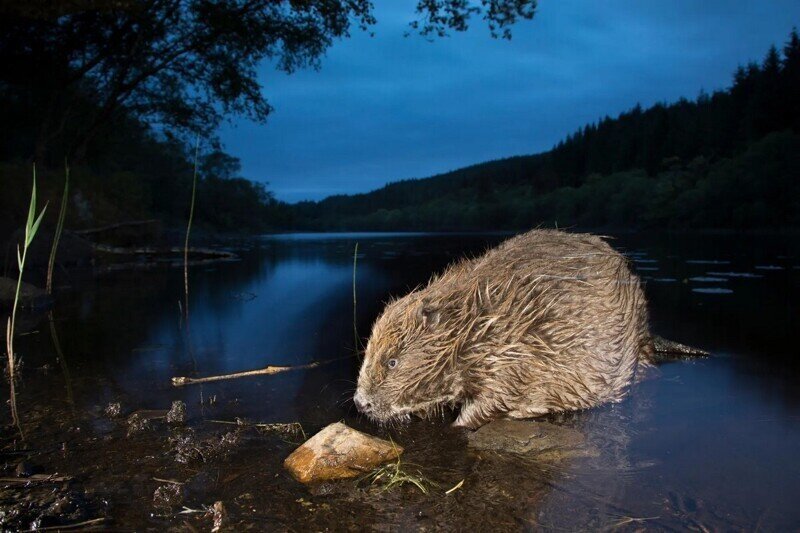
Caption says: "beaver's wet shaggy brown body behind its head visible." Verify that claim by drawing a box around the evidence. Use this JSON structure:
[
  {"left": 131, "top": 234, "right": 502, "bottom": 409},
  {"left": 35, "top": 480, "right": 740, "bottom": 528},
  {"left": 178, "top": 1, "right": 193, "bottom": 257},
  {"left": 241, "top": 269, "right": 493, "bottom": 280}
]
[{"left": 434, "top": 230, "right": 652, "bottom": 425}]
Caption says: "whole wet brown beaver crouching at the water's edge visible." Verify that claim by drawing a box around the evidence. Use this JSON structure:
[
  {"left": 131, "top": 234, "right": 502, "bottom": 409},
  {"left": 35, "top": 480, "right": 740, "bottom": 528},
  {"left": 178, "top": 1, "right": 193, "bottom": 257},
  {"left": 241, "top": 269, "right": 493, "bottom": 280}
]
[{"left": 353, "top": 229, "right": 704, "bottom": 429}]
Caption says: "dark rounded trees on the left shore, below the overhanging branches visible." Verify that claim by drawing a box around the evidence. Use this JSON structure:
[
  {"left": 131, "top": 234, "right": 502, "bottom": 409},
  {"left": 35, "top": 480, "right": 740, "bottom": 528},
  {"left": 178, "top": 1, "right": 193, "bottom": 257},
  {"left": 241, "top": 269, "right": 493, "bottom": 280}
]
[{"left": 0, "top": 115, "right": 291, "bottom": 238}]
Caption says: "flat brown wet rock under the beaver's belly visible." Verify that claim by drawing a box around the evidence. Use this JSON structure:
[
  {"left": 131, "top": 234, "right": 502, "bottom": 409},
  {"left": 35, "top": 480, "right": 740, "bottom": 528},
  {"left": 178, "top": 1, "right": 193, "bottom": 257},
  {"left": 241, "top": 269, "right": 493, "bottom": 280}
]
[{"left": 467, "top": 420, "right": 596, "bottom": 460}]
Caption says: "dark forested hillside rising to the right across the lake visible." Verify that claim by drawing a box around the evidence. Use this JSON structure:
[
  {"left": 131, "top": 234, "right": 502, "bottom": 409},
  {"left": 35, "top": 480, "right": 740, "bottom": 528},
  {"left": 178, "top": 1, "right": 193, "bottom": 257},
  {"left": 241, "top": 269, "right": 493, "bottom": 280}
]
[{"left": 294, "top": 31, "right": 800, "bottom": 230}]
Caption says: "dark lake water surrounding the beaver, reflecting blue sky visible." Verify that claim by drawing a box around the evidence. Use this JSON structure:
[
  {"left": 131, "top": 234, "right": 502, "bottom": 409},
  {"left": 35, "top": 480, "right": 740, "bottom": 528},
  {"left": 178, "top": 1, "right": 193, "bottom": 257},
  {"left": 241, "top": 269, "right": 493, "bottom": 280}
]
[{"left": 0, "top": 234, "right": 800, "bottom": 530}]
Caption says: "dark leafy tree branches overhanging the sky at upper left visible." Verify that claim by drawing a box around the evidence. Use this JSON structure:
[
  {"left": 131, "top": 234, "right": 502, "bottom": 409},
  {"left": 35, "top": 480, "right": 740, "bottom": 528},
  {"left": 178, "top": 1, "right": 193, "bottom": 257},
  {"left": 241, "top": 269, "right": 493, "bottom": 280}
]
[{"left": 0, "top": 0, "right": 535, "bottom": 160}]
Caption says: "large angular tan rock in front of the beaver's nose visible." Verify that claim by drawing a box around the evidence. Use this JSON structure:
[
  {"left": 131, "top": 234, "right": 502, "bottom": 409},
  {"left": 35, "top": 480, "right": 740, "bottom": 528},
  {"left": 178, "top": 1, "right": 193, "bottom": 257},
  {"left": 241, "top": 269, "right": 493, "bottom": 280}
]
[{"left": 283, "top": 422, "right": 403, "bottom": 483}]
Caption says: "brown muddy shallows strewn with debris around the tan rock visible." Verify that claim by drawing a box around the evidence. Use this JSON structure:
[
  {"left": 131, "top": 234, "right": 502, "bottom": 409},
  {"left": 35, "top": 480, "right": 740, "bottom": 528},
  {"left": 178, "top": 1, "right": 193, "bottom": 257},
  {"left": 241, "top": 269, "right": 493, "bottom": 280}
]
[{"left": 0, "top": 388, "right": 592, "bottom": 531}]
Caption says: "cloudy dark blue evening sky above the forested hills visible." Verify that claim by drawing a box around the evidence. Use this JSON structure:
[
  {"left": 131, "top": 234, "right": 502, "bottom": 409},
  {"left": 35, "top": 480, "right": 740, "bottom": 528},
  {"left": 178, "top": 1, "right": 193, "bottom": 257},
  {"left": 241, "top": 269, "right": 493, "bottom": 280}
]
[{"left": 221, "top": 0, "right": 800, "bottom": 202}]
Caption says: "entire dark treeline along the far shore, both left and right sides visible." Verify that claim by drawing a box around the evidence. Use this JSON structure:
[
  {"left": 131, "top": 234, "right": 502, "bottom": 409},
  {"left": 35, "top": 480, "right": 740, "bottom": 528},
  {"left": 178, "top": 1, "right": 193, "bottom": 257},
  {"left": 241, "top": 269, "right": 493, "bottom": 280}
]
[{"left": 0, "top": 31, "right": 800, "bottom": 237}]
